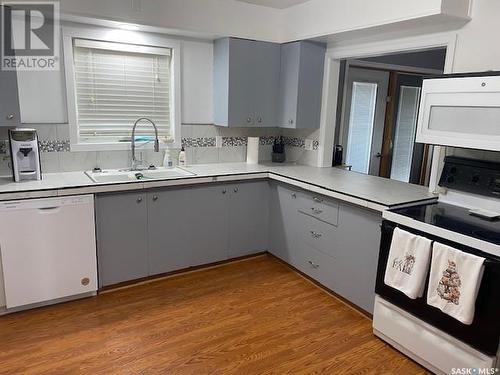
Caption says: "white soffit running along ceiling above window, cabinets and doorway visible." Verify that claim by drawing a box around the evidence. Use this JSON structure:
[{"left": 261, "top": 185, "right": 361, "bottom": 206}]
[{"left": 57, "top": 0, "right": 470, "bottom": 43}]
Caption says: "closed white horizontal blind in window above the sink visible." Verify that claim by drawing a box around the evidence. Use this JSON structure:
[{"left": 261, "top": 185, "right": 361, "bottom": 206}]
[{"left": 73, "top": 39, "right": 172, "bottom": 143}]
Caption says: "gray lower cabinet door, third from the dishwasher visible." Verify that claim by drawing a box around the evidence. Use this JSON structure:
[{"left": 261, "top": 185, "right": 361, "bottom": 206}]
[{"left": 186, "top": 185, "right": 229, "bottom": 266}]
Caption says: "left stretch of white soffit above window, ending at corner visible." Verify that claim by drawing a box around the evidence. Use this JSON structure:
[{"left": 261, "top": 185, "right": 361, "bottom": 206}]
[{"left": 61, "top": 0, "right": 282, "bottom": 41}]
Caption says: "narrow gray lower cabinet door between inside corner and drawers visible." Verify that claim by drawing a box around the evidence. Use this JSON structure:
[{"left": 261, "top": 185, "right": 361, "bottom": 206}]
[{"left": 269, "top": 183, "right": 298, "bottom": 262}]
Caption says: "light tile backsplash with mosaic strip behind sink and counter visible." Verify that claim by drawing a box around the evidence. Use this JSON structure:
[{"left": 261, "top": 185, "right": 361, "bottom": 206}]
[{"left": 0, "top": 124, "right": 319, "bottom": 175}]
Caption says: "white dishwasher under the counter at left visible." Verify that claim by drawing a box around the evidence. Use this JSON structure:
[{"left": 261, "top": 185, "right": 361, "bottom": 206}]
[{"left": 0, "top": 195, "right": 97, "bottom": 309}]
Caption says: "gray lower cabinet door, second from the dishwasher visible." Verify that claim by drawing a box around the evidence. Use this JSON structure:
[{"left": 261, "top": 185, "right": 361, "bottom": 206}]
[{"left": 147, "top": 188, "right": 193, "bottom": 275}]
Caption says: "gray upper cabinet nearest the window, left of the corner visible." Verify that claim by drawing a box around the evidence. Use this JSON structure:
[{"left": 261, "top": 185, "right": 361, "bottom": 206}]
[{"left": 214, "top": 38, "right": 280, "bottom": 127}]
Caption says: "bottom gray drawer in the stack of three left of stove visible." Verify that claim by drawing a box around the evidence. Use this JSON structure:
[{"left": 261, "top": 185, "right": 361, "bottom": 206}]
[{"left": 291, "top": 241, "right": 337, "bottom": 289}]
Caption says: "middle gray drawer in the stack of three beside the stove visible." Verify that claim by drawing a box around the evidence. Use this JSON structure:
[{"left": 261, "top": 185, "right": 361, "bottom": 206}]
[{"left": 297, "top": 212, "right": 337, "bottom": 257}]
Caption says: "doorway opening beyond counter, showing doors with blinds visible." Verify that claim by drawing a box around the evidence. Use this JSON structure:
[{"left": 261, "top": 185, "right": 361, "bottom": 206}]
[{"left": 335, "top": 48, "right": 446, "bottom": 185}]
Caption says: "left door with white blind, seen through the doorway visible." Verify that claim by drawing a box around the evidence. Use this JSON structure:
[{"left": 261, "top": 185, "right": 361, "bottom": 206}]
[{"left": 341, "top": 68, "right": 389, "bottom": 176}]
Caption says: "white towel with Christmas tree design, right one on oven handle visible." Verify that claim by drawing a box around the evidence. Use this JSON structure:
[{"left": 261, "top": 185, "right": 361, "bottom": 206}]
[{"left": 427, "top": 242, "right": 484, "bottom": 324}]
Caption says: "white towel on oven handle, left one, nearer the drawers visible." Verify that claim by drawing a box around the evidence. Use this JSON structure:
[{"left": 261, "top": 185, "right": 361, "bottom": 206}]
[{"left": 384, "top": 228, "right": 432, "bottom": 299}]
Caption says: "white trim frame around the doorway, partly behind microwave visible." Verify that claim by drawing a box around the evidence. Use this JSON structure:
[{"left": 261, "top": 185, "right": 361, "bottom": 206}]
[{"left": 317, "top": 32, "right": 458, "bottom": 192}]
